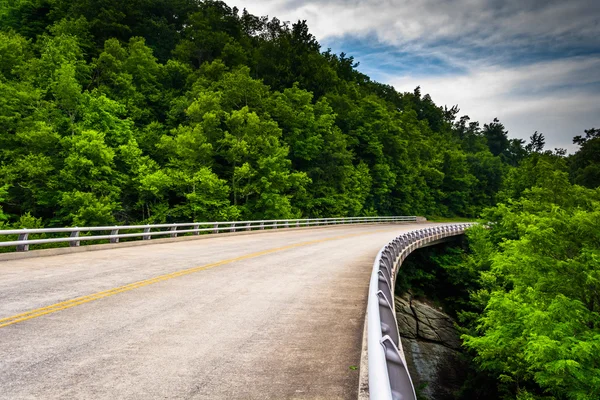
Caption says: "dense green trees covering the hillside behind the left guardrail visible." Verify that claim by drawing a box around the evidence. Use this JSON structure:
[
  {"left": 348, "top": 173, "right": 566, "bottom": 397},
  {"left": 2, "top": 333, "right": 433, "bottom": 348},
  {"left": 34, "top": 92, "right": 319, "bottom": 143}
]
[{"left": 0, "top": 0, "right": 540, "bottom": 227}]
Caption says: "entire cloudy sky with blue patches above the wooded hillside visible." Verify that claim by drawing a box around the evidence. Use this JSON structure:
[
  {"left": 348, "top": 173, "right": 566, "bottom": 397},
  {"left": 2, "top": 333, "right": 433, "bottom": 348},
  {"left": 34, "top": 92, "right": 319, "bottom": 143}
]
[{"left": 225, "top": 0, "right": 600, "bottom": 152}]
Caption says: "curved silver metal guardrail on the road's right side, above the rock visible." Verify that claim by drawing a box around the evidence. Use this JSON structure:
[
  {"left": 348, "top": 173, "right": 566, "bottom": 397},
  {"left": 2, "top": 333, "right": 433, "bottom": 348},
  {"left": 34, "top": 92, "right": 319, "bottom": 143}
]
[{"left": 367, "top": 223, "right": 474, "bottom": 400}]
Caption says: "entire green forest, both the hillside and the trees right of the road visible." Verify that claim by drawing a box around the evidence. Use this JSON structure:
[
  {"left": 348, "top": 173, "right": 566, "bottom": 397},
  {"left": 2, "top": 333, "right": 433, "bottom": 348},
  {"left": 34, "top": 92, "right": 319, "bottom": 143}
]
[{"left": 0, "top": 0, "right": 600, "bottom": 400}]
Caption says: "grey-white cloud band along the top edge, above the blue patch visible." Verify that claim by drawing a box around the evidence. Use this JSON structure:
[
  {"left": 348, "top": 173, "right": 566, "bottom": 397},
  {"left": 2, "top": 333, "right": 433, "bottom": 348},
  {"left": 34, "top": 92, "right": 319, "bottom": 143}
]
[{"left": 228, "top": 0, "right": 600, "bottom": 55}]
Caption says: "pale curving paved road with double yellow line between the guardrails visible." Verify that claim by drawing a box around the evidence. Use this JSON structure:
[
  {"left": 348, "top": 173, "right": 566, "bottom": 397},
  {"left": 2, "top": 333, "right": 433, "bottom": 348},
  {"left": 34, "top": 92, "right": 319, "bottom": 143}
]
[{"left": 0, "top": 224, "right": 430, "bottom": 400}]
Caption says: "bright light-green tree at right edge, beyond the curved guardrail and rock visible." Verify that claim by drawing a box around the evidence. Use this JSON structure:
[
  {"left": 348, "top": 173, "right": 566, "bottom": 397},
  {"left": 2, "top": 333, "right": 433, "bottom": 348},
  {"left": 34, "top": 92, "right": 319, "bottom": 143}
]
[{"left": 463, "top": 159, "right": 600, "bottom": 399}]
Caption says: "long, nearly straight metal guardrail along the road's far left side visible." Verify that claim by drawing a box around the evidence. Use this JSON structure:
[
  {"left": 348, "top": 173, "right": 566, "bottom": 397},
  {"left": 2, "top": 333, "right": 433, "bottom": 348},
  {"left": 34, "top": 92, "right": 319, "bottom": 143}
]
[{"left": 0, "top": 216, "right": 417, "bottom": 251}]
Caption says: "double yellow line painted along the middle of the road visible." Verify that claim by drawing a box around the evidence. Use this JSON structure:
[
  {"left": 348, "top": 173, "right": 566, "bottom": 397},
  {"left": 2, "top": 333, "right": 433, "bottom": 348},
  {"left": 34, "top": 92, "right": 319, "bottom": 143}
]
[{"left": 0, "top": 229, "right": 404, "bottom": 328}]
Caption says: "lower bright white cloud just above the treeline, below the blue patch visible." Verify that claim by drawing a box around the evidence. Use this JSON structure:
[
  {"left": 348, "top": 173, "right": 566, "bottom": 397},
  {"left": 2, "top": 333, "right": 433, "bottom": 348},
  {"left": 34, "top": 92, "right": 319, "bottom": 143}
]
[{"left": 385, "top": 57, "right": 600, "bottom": 150}]
